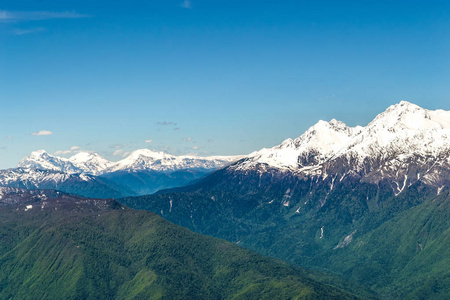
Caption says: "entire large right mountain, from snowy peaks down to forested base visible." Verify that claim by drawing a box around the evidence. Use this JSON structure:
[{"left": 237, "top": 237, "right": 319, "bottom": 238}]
[{"left": 120, "top": 101, "right": 450, "bottom": 299}]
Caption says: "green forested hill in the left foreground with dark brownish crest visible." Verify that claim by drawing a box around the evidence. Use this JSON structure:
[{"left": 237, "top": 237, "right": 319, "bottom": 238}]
[{"left": 0, "top": 195, "right": 362, "bottom": 299}]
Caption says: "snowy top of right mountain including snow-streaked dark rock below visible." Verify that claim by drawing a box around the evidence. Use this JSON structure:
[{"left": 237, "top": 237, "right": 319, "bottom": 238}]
[{"left": 231, "top": 101, "right": 450, "bottom": 194}]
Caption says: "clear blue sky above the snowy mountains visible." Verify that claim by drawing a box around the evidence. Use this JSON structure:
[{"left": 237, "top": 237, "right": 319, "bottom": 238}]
[{"left": 0, "top": 0, "right": 450, "bottom": 168}]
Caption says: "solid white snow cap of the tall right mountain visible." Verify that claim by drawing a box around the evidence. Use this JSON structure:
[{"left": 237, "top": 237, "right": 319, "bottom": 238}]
[{"left": 234, "top": 101, "right": 450, "bottom": 172}]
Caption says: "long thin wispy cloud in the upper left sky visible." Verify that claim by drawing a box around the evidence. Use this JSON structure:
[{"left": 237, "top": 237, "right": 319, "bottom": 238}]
[{"left": 0, "top": 10, "right": 90, "bottom": 22}]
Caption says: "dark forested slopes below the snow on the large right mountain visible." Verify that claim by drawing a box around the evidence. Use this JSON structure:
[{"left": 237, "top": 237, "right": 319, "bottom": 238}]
[{"left": 120, "top": 169, "right": 450, "bottom": 299}]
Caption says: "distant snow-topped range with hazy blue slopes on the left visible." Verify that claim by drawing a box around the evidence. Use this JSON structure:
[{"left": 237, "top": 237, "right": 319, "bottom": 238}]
[{"left": 0, "top": 149, "right": 240, "bottom": 198}]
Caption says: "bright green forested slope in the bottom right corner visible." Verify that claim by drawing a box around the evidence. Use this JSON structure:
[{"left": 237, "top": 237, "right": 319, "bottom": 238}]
[{"left": 324, "top": 193, "right": 450, "bottom": 299}]
